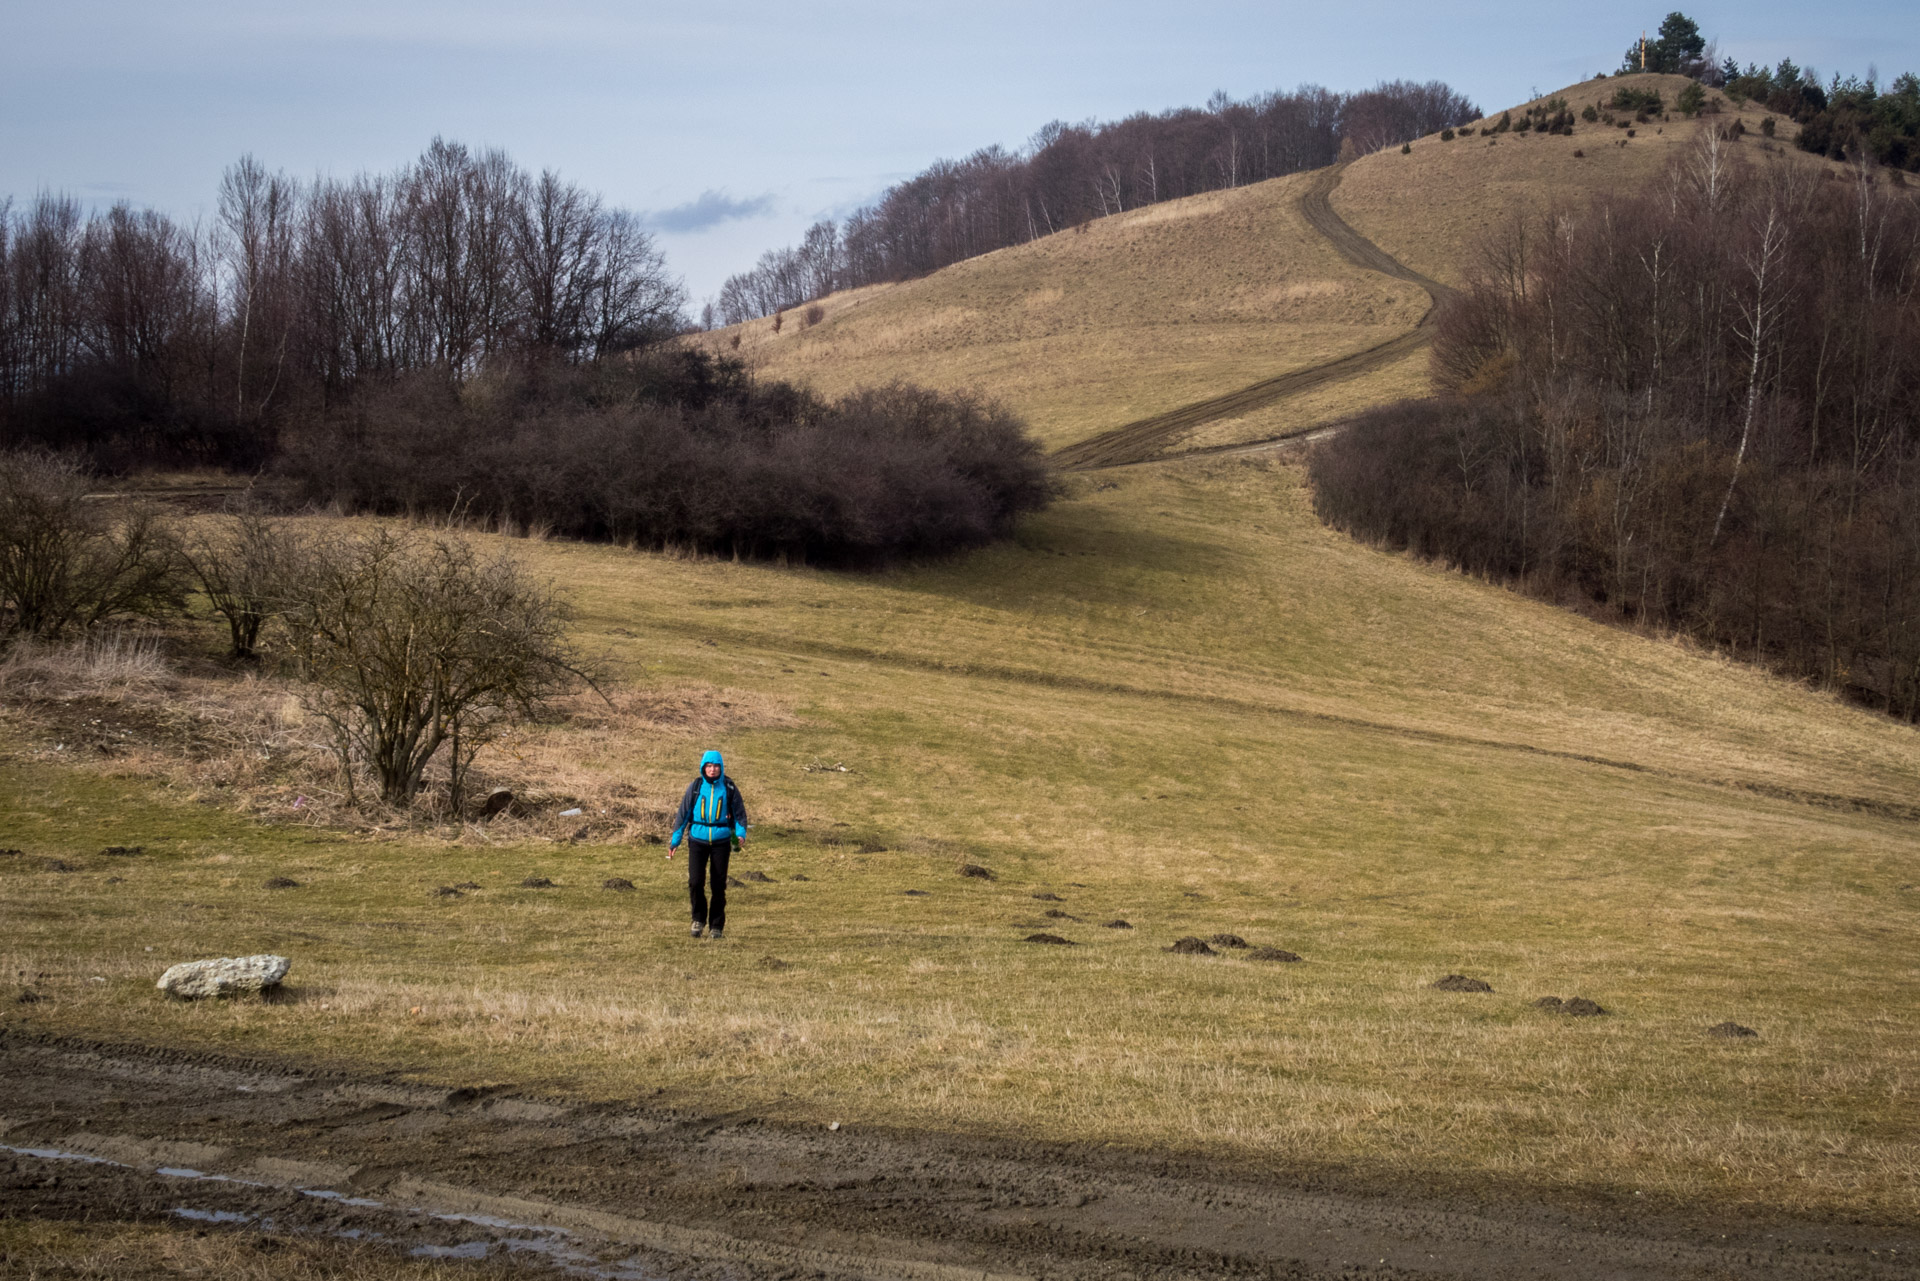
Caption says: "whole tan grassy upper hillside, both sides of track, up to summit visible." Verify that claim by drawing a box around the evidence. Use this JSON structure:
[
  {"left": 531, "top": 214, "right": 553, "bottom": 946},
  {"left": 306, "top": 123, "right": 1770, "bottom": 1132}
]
[{"left": 699, "top": 75, "right": 1826, "bottom": 467}]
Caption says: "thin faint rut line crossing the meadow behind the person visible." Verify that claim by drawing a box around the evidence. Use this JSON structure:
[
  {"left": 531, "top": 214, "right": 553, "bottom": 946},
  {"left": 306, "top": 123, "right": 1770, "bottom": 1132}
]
[{"left": 649, "top": 618, "right": 1920, "bottom": 824}]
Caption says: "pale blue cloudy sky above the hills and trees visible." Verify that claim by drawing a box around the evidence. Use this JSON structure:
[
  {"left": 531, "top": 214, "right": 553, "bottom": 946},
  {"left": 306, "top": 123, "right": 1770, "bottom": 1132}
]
[{"left": 0, "top": 0, "right": 1920, "bottom": 305}]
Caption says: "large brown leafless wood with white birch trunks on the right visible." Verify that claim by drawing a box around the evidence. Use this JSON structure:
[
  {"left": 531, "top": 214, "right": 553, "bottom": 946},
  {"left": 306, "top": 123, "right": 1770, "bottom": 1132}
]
[{"left": 1311, "top": 133, "right": 1920, "bottom": 720}]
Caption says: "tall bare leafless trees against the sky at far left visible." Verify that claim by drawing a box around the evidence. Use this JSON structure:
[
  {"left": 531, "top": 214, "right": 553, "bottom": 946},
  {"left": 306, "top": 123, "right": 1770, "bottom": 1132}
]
[{"left": 0, "top": 140, "right": 684, "bottom": 471}]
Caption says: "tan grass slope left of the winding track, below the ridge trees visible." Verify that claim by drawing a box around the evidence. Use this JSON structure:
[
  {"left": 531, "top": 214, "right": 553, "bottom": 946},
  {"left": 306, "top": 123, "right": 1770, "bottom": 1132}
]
[{"left": 701, "top": 175, "right": 1428, "bottom": 447}]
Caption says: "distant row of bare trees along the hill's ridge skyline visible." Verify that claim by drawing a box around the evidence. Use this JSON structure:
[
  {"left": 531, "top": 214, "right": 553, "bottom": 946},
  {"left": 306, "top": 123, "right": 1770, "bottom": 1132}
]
[{"left": 705, "top": 81, "right": 1480, "bottom": 325}]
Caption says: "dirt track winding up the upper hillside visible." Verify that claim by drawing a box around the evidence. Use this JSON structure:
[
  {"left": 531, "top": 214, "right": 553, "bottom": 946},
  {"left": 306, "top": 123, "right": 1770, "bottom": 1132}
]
[{"left": 1054, "top": 165, "right": 1453, "bottom": 471}]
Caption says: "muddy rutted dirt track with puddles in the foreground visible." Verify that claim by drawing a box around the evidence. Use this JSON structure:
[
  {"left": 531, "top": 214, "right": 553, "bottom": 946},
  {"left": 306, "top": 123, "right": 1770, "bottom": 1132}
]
[{"left": 0, "top": 1033, "right": 1920, "bottom": 1281}]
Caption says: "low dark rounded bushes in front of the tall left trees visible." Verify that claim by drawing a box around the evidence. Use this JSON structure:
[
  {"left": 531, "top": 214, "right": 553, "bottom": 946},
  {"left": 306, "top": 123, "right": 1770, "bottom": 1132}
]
[{"left": 284, "top": 351, "right": 1052, "bottom": 565}]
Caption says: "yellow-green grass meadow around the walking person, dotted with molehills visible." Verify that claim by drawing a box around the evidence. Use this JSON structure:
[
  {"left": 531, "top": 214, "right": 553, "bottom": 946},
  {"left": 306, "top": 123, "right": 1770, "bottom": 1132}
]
[{"left": 0, "top": 461, "right": 1920, "bottom": 1221}]
